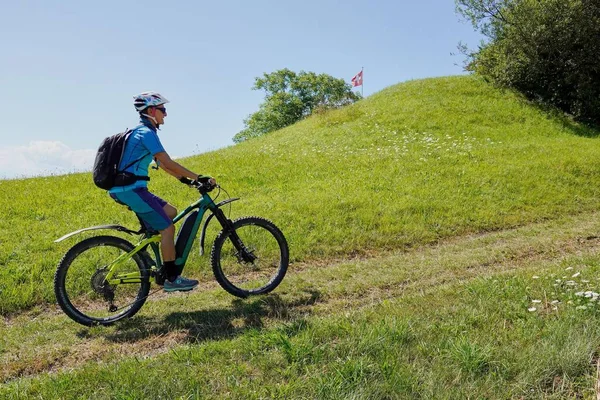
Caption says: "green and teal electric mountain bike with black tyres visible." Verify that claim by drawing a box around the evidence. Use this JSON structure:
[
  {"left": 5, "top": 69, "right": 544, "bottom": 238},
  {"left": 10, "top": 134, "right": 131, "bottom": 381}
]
[{"left": 54, "top": 182, "right": 289, "bottom": 326}]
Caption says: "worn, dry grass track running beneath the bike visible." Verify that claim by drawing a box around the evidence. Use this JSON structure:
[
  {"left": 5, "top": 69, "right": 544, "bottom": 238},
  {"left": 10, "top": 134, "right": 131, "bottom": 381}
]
[{"left": 0, "top": 213, "right": 600, "bottom": 383}]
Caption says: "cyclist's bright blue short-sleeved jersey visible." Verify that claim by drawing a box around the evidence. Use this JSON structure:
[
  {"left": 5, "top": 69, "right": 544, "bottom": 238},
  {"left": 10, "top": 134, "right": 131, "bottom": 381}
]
[{"left": 108, "top": 118, "right": 165, "bottom": 193}]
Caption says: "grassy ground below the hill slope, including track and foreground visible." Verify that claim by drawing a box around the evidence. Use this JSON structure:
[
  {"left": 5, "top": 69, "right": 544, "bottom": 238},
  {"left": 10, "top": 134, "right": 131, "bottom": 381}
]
[{"left": 0, "top": 213, "right": 600, "bottom": 399}]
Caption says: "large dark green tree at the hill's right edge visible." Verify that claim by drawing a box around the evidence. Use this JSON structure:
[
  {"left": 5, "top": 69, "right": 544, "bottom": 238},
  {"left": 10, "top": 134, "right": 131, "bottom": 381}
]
[{"left": 456, "top": 0, "right": 600, "bottom": 124}]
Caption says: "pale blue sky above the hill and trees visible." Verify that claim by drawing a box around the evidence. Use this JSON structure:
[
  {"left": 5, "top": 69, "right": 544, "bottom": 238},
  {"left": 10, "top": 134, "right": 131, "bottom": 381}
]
[{"left": 0, "top": 0, "right": 481, "bottom": 178}]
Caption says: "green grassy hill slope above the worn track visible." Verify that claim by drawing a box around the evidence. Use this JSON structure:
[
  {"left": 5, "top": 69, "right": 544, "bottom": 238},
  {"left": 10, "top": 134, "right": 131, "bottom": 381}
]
[{"left": 0, "top": 77, "right": 600, "bottom": 314}]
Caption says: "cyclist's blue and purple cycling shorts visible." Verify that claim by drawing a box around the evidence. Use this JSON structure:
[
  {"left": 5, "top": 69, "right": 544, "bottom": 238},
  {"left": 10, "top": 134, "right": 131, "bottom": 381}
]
[{"left": 110, "top": 187, "right": 173, "bottom": 231}]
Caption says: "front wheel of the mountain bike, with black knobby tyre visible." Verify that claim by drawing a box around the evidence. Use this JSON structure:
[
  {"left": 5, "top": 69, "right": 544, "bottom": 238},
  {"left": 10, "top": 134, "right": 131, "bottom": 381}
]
[{"left": 210, "top": 217, "right": 289, "bottom": 297}]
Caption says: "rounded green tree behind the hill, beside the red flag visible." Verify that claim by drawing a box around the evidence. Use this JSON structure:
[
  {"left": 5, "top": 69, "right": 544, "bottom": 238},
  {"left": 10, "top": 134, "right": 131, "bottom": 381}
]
[{"left": 233, "top": 68, "right": 360, "bottom": 143}]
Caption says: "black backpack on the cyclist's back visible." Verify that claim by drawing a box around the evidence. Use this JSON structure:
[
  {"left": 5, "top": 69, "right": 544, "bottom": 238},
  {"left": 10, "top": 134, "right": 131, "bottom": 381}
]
[{"left": 92, "top": 129, "right": 150, "bottom": 190}]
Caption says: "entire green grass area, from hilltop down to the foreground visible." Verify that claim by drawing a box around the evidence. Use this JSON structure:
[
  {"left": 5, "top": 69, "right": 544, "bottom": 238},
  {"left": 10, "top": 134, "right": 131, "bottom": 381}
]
[{"left": 0, "top": 77, "right": 600, "bottom": 399}]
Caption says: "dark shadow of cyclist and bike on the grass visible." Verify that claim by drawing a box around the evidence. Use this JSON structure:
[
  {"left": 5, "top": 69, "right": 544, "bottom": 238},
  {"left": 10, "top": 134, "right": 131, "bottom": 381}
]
[{"left": 79, "top": 290, "right": 321, "bottom": 343}]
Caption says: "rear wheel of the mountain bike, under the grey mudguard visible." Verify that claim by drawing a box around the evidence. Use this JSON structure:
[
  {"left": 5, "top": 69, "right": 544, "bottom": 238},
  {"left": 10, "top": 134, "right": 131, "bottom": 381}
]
[{"left": 54, "top": 236, "right": 150, "bottom": 326}]
